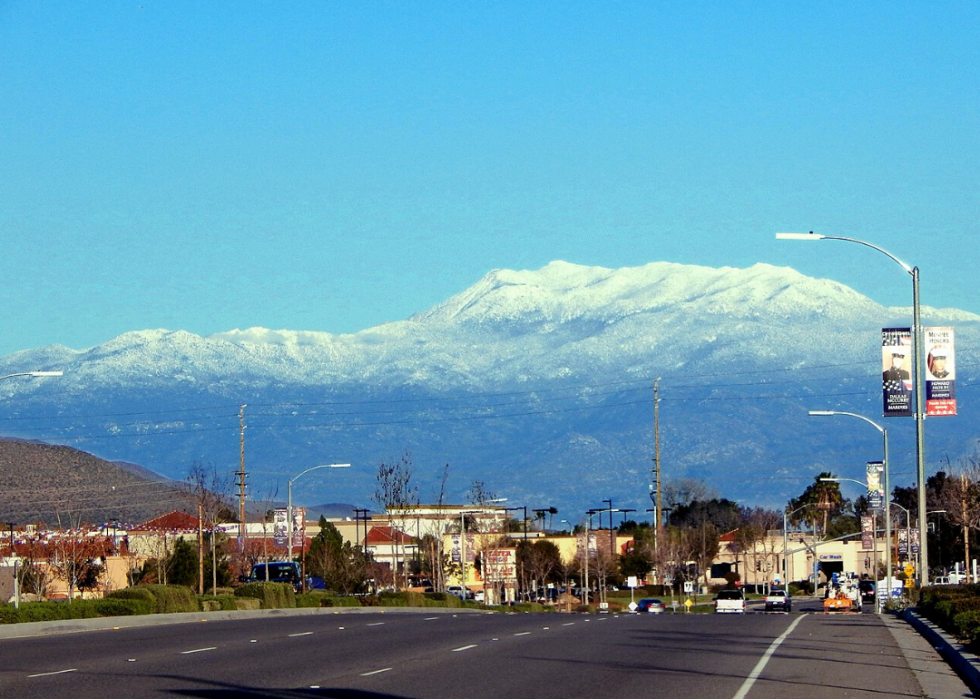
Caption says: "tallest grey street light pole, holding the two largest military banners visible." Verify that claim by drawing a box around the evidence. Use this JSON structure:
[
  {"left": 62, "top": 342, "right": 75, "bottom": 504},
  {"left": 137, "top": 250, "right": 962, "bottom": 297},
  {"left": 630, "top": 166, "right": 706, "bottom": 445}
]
[{"left": 776, "top": 231, "right": 929, "bottom": 594}]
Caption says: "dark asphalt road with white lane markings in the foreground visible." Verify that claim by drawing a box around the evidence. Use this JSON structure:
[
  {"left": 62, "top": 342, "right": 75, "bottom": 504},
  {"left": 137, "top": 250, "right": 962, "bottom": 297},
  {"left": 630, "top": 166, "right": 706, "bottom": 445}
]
[{"left": 0, "top": 610, "right": 956, "bottom": 699}]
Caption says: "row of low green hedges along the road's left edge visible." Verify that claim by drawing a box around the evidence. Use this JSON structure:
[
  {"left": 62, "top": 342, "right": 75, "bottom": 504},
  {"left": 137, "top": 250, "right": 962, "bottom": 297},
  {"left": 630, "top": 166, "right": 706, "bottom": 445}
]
[{"left": 0, "top": 582, "right": 512, "bottom": 624}]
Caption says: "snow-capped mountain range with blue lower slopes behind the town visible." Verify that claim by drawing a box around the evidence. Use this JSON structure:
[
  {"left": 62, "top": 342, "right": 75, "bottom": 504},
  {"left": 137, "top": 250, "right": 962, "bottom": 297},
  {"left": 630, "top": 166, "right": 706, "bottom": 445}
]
[{"left": 0, "top": 262, "right": 980, "bottom": 516}]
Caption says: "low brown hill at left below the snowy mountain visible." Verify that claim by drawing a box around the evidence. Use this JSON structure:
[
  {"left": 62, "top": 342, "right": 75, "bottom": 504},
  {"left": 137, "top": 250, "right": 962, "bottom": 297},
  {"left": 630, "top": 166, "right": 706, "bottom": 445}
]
[{"left": 0, "top": 439, "right": 196, "bottom": 527}]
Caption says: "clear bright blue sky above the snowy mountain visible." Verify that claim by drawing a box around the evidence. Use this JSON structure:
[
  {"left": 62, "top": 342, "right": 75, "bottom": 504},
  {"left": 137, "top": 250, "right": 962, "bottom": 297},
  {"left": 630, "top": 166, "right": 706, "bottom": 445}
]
[{"left": 0, "top": 0, "right": 980, "bottom": 356}]
